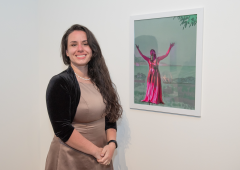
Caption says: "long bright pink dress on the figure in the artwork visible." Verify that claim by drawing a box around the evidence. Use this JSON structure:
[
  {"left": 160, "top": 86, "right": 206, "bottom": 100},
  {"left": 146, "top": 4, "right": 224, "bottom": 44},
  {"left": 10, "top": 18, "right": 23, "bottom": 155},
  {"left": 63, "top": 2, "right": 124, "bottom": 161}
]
[{"left": 142, "top": 58, "right": 164, "bottom": 104}]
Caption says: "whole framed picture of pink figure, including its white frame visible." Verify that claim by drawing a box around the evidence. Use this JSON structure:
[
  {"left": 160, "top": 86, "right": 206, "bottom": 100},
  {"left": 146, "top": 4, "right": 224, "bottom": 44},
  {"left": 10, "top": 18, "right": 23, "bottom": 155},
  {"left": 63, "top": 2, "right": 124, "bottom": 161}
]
[{"left": 130, "top": 8, "right": 203, "bottom": 117}]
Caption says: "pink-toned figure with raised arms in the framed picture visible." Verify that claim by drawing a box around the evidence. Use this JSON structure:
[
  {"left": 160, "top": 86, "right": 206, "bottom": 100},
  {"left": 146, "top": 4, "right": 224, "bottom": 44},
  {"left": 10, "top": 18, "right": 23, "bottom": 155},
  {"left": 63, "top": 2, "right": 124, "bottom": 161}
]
[{"left": 136, "top": 43, "right": 175, "bottom": 104}]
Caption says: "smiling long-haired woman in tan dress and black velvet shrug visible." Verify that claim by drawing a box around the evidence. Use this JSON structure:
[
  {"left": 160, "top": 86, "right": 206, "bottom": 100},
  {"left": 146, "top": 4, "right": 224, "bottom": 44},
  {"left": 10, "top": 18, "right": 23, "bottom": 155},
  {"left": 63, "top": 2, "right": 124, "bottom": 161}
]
[{"left": 45, "top": 24, "right": 122, "bottom": 170}]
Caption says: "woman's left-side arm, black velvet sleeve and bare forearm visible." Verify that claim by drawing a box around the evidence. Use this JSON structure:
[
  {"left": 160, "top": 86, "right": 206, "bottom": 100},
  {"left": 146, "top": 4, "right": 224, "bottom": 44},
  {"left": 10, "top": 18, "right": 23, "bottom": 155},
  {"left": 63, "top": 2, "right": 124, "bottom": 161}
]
[{"left": 46, "top": 76, "right": 102, "bottom": 159}]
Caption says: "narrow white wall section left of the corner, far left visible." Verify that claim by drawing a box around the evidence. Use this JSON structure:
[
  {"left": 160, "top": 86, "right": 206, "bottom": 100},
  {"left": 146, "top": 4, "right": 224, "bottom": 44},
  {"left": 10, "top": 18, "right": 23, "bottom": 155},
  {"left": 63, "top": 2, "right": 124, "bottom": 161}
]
[{"left": 0, "top": 0, "right": 40, "bottom": 170}]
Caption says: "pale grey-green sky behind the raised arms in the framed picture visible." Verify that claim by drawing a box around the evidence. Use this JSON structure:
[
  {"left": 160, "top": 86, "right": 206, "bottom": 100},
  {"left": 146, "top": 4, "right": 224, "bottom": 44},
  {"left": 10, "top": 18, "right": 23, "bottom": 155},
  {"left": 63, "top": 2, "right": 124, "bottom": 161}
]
[{"left": 134, "top": 17, "right": 197, "bottom": 66}]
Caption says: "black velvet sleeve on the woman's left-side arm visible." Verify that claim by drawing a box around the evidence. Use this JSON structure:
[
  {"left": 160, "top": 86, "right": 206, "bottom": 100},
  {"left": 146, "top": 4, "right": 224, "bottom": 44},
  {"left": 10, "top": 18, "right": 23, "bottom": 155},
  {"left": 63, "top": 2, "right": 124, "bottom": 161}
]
[{"left": 46, "top": 75, "right": 74, "bottom": 142}]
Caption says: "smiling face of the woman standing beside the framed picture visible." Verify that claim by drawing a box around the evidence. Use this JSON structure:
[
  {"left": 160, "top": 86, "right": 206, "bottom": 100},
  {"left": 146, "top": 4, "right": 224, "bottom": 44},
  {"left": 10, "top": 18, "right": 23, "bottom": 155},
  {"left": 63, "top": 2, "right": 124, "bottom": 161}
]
[{"left": 66, "top": 31, "right": 92, "bottom": 66}]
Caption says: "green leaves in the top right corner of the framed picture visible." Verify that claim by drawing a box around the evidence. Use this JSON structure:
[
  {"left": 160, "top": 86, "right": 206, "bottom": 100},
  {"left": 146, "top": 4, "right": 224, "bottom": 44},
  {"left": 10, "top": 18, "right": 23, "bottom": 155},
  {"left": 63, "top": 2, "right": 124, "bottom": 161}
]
[{"left": 173, "top": 14, "right": 197, "bottom": 29}]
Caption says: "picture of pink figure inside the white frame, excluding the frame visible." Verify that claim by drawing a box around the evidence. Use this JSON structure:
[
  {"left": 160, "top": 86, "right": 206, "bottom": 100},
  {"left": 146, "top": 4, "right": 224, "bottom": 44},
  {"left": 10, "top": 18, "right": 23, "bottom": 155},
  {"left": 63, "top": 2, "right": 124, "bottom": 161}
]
[{"left": 134, "top": 15, "right": 197, "bottom": 110}]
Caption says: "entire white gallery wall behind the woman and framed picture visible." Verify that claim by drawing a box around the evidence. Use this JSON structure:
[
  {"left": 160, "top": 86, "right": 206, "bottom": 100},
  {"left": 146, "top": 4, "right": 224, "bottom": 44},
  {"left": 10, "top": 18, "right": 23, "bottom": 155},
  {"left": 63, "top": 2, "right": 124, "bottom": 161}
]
[{"left": 0, "top": 0, "right": 240, "bottom": 170}]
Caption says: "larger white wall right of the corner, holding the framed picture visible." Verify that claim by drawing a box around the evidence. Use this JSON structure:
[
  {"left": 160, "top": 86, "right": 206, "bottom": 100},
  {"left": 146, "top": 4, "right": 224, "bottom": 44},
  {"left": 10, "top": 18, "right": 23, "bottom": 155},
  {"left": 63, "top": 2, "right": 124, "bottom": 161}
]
[{"left": 39, "top": 0, "right": 240, "bottom": 170}]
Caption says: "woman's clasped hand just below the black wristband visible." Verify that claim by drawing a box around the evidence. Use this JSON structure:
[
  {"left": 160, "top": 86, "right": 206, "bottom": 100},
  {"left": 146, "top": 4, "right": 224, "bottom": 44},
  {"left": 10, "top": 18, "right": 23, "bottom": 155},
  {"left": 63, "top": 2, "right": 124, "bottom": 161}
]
[{"left": 97, "top": 142, "right": 116, "bottom": 165}]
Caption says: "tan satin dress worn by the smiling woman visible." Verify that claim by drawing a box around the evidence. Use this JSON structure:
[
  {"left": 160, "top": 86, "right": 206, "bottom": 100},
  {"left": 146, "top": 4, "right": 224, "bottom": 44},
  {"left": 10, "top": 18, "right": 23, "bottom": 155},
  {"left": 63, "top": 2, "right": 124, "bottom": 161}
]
[{"left": 45, "top": 82, "right": 113, "bottom": 170}]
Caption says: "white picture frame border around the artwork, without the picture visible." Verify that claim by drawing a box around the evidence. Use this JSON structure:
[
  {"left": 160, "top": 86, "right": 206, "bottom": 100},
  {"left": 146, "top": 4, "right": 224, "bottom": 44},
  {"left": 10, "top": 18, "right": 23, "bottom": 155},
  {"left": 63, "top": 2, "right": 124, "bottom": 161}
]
[{"left": 129, "top": 8, "right": 203, "bottom": 117}]
